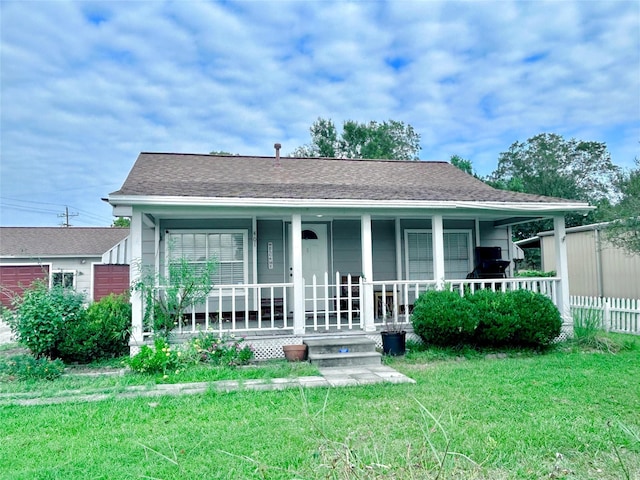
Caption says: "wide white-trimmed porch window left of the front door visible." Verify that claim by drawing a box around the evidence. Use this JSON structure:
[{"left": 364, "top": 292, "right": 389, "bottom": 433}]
[{"left": 167, "top": 230, "right": 249, "bottom": 285}]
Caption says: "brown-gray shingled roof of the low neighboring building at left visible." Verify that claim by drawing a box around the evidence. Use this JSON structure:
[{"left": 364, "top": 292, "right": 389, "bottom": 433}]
[{"left": 0, "top": 227, "right": 129, "bottom": 257}]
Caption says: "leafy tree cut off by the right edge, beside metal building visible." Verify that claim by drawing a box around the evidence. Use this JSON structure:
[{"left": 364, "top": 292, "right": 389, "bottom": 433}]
[{"left": 607, "top": 158, "right": 640, "bottom": 253}]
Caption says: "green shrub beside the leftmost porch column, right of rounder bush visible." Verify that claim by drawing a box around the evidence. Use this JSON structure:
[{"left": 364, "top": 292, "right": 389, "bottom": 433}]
[{"left": 60, "top": 294, "right": 131, "bottom": 363}]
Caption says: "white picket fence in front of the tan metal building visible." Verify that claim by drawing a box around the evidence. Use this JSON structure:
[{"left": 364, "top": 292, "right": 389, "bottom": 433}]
[{"left": 571, "top": 296, "right": 640, "bottom": 335}]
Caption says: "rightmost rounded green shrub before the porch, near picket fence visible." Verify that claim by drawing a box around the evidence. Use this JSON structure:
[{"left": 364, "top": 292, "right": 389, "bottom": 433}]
[{"left": 504, "top": 290, "right": 562, "bottom": 347}]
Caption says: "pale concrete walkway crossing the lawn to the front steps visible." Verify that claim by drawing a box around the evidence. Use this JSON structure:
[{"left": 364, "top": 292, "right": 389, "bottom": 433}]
[{"left": 0, "top": 365, "right": 415, "bottom": 406}]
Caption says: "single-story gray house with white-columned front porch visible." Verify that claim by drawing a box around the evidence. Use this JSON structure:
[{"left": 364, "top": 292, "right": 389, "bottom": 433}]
[{"left": 107, "top": 148, "right": 590, "bottom": 357}]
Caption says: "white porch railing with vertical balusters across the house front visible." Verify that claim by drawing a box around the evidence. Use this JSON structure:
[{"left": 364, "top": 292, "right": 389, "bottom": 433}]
[{"left": 143, "top": 272, "right": 560, "bottom": 336}]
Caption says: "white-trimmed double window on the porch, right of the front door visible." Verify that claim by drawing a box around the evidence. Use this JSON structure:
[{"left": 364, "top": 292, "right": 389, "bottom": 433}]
[{"left": 404, "top": 229, "right": 473, "bottom": 280}]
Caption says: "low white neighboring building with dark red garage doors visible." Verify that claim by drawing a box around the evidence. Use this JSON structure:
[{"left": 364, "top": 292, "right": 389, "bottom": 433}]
[{"left": 0, "top": 227, "right": 129, "bottom": 306}]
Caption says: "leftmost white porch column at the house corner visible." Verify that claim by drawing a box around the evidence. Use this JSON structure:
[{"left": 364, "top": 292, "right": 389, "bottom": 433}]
[{"left": 129, "top": 209, "right": 144, "bottom": 356}]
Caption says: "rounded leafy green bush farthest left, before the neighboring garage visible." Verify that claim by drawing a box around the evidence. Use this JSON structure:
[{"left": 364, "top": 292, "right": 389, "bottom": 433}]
[{"left": 8, "top": 281, "right": 85, "bottom": 358}]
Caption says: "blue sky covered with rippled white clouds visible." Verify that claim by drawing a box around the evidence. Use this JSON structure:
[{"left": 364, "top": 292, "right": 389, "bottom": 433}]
[{"left": 0, "top": 0, "right": 640, "bottom": 226}]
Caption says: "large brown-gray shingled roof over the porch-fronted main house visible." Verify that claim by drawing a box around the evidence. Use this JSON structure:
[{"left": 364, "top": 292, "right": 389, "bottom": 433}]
[{"left": 111, "top": 152, "right": 568, "bottom": 202}]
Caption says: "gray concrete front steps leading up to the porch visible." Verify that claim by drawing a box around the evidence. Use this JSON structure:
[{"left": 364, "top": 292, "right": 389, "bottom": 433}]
[{"left": 303, "top": 336, "right": 382, "bottom": 367}]
